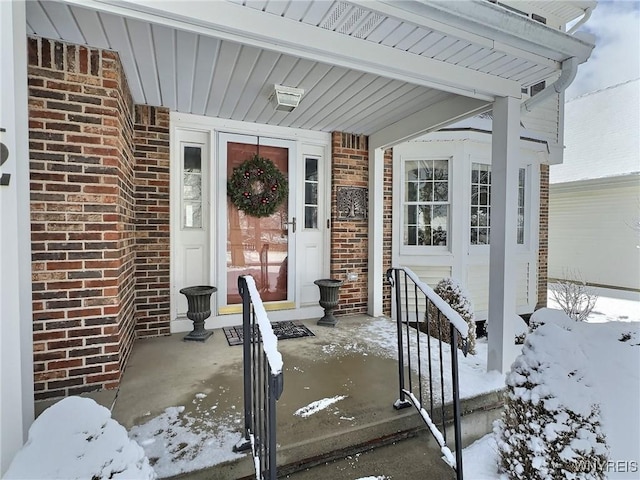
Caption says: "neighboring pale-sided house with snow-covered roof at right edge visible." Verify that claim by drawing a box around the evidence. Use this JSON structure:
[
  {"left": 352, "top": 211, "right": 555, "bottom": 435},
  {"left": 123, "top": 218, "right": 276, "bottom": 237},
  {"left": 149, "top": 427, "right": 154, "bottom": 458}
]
[{"left": 549, "top": 79, "right": 640, "bottom": 291}]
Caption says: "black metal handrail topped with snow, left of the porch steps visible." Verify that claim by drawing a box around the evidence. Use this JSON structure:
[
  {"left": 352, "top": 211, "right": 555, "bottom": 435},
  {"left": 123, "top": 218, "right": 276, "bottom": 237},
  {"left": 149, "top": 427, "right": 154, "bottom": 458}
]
[{"left": 234, "top": 275, "right": 284, "bottom": 480}]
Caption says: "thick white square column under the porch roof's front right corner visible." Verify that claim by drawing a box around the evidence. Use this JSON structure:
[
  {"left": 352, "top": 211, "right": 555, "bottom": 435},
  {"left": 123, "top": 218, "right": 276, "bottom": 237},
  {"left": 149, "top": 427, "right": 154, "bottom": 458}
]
[{"left": 487, "top": 97, "right": 520, "bottom": 372}]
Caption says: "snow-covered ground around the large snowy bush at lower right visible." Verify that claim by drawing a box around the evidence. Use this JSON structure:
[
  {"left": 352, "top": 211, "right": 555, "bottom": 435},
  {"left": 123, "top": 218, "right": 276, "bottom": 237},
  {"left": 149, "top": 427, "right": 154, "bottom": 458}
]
[{"left": 463, "top": 291, "right": 640, "bottom": 480}]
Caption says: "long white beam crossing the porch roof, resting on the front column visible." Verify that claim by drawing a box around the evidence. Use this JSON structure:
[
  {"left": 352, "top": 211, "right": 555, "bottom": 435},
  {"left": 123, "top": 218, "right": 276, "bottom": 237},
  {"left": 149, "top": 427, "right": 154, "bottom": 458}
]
[{"left": 66, "top": 0, "right": 521, "bottom": 101}]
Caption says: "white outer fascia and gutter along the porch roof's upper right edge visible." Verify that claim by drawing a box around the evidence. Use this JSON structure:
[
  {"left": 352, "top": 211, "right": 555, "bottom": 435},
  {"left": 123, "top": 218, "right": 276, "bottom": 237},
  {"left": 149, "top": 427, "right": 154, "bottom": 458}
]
[{"left": 364, "top": 0, "right": 594, "bottom": 63}]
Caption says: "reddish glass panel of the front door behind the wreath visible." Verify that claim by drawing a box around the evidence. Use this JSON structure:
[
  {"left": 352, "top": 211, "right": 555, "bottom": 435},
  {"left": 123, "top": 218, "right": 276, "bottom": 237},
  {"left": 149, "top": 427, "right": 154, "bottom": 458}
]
[{"left": 227, "top": 142, "right": 289, "bottom": 305}]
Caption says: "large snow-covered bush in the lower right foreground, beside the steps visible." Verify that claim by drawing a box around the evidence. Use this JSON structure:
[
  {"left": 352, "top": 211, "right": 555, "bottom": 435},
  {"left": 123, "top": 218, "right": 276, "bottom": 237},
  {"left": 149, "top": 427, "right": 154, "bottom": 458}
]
[{"left": 494, "top": 309, "right": 608, "bottom": 480}]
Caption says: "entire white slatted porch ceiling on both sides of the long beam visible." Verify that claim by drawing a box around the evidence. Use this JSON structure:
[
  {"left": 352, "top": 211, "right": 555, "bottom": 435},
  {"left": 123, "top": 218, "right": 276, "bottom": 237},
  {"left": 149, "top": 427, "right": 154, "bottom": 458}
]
[{"left": 27, "top": 0, "right": 592, "bottom": 134}]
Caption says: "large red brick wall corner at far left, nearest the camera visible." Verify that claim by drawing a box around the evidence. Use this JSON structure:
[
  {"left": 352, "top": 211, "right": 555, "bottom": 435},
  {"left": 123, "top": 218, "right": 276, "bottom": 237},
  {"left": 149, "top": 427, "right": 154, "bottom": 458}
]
[{"left": 28, "top": 38, "right": 160, "bottom": 400}]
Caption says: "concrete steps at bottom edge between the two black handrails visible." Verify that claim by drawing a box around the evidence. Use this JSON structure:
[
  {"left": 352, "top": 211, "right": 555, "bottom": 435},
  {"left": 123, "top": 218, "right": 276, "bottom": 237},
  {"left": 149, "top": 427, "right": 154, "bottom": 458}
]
[{"left": 173, "top": 392, "right": 503, "bottom": 480}]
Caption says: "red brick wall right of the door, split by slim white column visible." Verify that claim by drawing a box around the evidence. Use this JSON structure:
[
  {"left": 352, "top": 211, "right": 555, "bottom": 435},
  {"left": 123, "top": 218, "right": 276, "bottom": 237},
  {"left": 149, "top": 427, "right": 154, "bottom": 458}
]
[{"left": 331, "top": 132, "right": 392, "bottom": 315}]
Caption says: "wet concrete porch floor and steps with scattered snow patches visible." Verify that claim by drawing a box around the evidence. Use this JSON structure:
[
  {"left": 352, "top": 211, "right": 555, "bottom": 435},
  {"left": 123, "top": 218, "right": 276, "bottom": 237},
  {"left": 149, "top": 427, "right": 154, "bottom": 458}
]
[{"left": 35, "top": 316, "right": 501, "bottom": 480}]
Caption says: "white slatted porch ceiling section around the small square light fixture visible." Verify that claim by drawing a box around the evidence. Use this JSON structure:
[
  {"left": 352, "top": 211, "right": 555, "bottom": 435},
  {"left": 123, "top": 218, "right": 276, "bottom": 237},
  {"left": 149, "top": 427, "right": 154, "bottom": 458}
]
[{"left": 27, "top": 2, "right": 460, "bottom": 134}]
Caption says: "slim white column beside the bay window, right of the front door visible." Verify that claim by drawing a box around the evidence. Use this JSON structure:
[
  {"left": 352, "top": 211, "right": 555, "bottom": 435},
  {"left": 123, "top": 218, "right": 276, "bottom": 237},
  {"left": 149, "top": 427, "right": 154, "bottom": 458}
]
[{"left": 367, "top": 147, "right": 385, "bottom": 317}]
